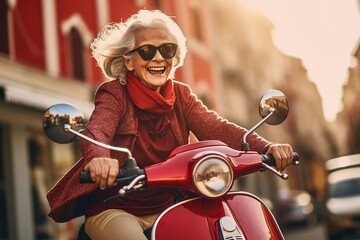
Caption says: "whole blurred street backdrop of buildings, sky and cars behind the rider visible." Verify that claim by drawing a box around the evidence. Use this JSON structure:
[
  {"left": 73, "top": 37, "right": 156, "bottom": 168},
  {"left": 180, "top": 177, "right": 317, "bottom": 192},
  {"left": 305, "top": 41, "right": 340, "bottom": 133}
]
[{"left": 0, "top": 0, "right": 360, "bottom": 240}]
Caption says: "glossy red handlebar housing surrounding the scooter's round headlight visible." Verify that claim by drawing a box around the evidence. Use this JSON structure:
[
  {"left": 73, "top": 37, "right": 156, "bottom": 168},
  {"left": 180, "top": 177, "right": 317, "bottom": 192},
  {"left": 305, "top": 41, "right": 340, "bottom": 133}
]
[{"left": 144, "top": 140, "right": 262, "bottom": 196}]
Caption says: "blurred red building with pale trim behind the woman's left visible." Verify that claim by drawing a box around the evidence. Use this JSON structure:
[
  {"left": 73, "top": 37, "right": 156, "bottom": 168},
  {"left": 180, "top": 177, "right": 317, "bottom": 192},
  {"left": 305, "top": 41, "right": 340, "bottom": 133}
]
[{"left": 0, "top": 0, "right": 217, "bottom": 239}]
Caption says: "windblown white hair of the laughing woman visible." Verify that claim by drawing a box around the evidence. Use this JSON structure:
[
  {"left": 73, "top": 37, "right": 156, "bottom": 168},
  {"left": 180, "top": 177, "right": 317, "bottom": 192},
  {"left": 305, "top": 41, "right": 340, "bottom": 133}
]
[{"left": 90, "top": 9, "right": 187, "bottom": 81}]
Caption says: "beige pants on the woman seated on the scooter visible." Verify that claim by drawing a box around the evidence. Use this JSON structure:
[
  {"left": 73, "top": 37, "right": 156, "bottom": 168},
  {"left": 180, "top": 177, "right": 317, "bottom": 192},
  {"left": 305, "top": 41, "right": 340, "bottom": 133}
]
[{"left": 85, "top": 209, "right": 159, "bottom": 240}]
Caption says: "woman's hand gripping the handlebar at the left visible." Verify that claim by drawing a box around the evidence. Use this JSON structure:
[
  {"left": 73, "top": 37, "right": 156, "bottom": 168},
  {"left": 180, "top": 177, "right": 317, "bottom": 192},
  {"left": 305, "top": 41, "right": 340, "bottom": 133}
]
[{"left": 84, "top": 158, "right": 119, "bottom": 190}]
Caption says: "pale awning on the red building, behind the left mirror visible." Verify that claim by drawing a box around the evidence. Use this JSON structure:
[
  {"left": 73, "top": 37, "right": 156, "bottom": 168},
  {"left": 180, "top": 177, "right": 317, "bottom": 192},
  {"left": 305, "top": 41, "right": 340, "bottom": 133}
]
[{"left": 2, "top": 85, "right": 94, "bottom": 119}]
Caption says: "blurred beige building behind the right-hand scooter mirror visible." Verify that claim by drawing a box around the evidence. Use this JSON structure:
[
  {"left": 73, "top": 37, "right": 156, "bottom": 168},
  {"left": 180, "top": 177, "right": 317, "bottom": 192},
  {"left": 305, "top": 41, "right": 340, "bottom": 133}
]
[{"left": 210, "top": 0, "right": 338, "bottom": 203}]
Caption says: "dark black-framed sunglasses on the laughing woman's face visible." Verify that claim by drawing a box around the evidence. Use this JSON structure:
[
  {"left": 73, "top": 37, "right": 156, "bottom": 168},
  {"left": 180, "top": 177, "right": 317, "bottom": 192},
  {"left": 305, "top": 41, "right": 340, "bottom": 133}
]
[{"left": 125, "top": 43, "right": 177, "bottom": 61}]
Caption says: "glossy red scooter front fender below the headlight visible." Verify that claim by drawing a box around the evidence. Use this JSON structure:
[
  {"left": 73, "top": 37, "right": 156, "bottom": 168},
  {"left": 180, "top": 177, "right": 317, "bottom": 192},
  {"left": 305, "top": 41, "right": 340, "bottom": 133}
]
[{"left": 151, "top": 192, "right": 284, "bottom": 240}]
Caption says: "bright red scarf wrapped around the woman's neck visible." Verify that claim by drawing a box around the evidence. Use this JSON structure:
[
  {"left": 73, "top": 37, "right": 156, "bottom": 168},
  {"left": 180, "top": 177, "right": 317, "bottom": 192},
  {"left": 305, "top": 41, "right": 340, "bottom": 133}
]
[{"left": 126, "top": 72, "right": 176, "bottom": 114}]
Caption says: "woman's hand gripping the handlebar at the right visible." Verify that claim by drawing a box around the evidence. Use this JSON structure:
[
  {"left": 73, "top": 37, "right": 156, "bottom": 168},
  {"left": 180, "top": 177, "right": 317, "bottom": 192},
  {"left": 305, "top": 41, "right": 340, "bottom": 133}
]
[{"left": 266, "top": 144, "right": 293, "bottom": 172}]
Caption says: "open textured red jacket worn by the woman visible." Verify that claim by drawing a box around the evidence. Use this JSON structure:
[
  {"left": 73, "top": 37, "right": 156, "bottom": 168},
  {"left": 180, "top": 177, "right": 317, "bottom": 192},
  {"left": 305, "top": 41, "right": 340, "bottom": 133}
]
[{"left": 47, "top": 80, "right": 269, "bottom": 222}]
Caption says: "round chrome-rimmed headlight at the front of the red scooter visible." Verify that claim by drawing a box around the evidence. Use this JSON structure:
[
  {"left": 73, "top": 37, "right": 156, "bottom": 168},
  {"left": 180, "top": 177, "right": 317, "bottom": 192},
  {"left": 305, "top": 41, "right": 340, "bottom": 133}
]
[{"left": 193, "top": 157, "right": 233, "bottom": 198}]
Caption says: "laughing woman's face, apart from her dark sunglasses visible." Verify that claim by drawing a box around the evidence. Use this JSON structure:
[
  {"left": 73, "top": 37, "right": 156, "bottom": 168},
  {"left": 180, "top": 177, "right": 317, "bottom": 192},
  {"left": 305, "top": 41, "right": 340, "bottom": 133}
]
[{"left": 125, "top": 28, "right": 175, "bottom": 91}]
